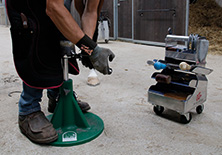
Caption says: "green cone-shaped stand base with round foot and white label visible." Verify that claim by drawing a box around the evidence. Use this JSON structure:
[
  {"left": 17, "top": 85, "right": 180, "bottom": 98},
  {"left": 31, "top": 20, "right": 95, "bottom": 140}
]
[{"left": 47, "top": 79, "right": 104, "bottom": 146}]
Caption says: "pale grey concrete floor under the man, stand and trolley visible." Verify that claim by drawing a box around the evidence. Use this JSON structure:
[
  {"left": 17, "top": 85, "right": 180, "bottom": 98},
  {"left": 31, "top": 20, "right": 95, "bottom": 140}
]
[{"left": 0, "top": 27, "right": 222, "bottom": 155}]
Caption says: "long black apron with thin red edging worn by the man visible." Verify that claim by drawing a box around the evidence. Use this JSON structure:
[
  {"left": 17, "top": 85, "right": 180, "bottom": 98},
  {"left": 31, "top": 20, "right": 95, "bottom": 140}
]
[{"left": 6, "top": 0, "right": 79, "bottom": 89}]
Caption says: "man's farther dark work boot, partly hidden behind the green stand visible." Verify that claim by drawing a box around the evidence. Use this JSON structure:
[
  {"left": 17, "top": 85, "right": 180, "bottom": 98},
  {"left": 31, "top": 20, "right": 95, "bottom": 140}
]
[{"left": 48, "top": 92, "right": 90, "bottom": 113}]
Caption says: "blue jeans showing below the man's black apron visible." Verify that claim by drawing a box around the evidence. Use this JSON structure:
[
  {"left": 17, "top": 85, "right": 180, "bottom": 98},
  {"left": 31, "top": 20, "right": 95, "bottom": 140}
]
[{"left": 18, "top": 83, "right": 59, "bottom": 115}]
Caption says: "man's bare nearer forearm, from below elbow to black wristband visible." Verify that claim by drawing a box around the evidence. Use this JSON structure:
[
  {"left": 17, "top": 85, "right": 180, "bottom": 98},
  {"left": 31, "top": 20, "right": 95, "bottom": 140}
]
[{"left": 46, "top": 0, "right": 85, "bottom": 44}]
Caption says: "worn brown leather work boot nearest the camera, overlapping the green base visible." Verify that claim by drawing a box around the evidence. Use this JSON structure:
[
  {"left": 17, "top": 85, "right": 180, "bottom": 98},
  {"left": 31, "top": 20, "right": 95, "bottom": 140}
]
[{"left": 19, "top": 111, "right": 58, "bottom": 144}]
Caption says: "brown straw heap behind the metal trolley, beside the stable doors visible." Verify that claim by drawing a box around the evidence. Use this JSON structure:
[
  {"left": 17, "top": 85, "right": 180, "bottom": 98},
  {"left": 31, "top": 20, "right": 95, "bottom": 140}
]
[{"left": 189, "top": 0, "right": 222, "bottom": 55}]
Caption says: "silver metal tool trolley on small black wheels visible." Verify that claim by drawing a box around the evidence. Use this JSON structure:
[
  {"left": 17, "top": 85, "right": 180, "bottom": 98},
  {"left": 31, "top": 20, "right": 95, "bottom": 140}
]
[{"left": 147, "top": 34, "right": 212, "bottom": 124}]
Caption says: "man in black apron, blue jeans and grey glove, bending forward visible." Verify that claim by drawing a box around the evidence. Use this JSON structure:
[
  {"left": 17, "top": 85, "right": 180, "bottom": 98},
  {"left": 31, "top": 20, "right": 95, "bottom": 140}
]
[{"left": 6, "top": 0, "right": 115, "bottom": 144}]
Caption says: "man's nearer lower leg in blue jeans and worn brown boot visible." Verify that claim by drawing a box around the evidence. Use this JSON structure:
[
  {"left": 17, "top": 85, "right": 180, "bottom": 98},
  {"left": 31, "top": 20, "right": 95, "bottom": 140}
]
[{"left": 19, "top": 83, "right": 58, "bottom": 144}]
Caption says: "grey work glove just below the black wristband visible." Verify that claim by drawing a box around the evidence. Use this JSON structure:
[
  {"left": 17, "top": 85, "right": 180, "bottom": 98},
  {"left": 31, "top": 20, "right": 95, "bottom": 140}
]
[{"left": 89, "top": 46, "right": 115, "bottom": 75}]
